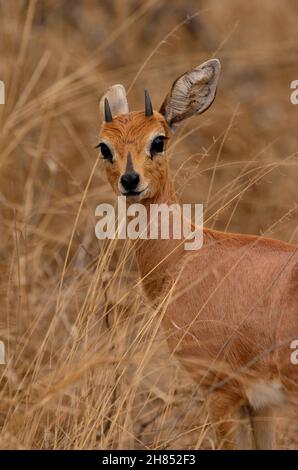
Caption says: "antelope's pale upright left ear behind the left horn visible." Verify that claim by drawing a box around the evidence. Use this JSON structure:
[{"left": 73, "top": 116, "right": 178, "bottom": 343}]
[{"left": 99, "top": 85, "right": 129, "bottom": 121}]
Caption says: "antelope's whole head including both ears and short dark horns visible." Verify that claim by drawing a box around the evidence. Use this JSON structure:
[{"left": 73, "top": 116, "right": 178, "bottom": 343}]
[{"left": 98, "top": 59, "right": 220, "bottom": 201}]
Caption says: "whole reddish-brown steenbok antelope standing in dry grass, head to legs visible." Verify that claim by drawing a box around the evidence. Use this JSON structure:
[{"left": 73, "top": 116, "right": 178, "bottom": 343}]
[{"left": 99, "top": 59, "right": 298, "bottom": 449}]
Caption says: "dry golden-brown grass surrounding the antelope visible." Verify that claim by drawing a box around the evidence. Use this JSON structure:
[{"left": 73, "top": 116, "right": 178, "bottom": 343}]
[{"left": 0, "top": 0, "right": 298, "bottom": 449}]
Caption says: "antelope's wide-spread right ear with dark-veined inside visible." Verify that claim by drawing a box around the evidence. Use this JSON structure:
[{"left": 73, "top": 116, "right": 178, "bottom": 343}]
[{"left": 159, "top": 59, "right": 220, "bottom": 126}]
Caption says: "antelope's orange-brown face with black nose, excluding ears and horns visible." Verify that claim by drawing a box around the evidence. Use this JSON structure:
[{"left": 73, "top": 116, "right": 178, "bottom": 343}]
[{"left": 99, "top": 112, "right": 169, "bottom": 201}]
